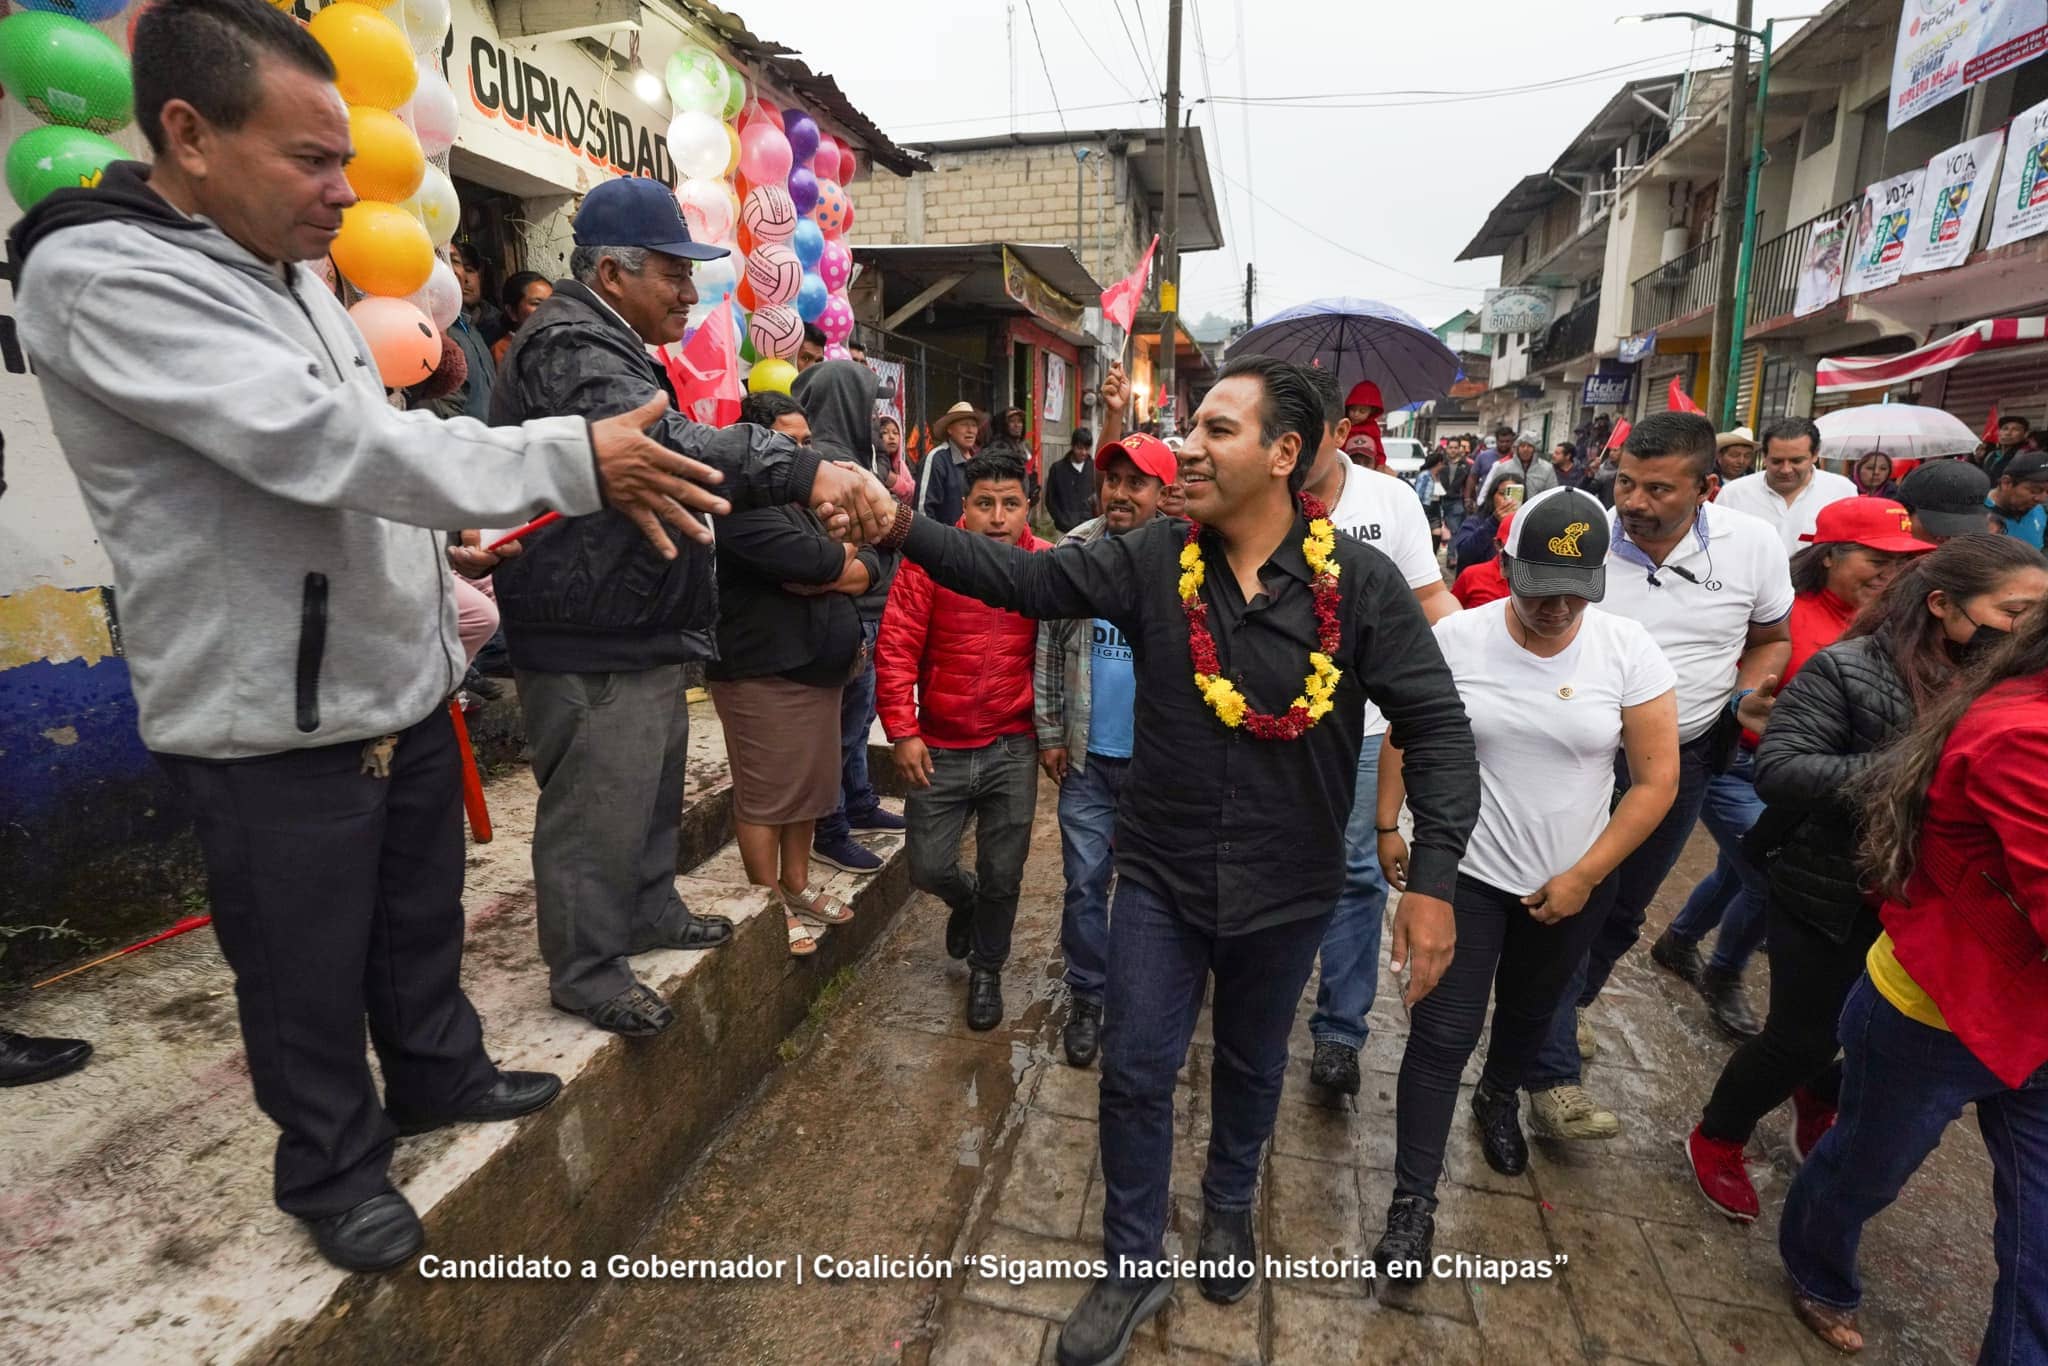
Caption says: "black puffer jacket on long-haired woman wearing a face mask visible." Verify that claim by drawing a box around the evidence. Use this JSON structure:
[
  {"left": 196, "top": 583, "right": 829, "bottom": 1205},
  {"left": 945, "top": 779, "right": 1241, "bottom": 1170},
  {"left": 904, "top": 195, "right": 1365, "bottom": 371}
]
[{"left": 1753, "top": 635, "right": 1913, "bottom": 942}]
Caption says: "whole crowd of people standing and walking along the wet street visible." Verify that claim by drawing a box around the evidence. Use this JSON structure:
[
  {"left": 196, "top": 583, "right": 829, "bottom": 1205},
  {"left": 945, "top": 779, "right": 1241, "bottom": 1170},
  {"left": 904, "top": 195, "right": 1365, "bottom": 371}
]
[{"left": 8, "top": 0, "right": 2048, "bottom": 1366}]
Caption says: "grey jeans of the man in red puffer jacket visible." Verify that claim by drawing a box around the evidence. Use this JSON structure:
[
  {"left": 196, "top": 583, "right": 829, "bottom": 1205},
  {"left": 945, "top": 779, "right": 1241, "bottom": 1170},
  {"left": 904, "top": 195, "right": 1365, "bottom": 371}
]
[{"left": 903, "top": 731, "right": 1038, "bottom": 973}]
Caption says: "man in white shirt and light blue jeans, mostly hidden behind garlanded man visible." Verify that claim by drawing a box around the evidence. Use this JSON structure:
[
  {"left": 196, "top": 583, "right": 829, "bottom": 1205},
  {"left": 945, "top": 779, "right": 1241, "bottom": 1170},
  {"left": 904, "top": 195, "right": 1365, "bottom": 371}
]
[{"left": 1303, "top": 369, "right": 1458, "bottom": 1096}]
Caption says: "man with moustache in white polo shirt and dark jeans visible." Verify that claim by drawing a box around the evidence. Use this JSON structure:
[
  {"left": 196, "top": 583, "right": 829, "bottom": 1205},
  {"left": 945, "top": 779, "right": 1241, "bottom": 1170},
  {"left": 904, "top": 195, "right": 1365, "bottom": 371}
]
[{"left": 1522, "top": 414, "right": 1785, "bottom": 1139}]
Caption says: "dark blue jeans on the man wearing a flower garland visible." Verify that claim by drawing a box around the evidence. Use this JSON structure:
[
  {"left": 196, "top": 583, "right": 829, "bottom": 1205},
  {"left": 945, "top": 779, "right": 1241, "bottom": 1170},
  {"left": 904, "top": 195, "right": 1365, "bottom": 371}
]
[{"left": 1102, "top": 877, "right": 1329, "bottom": 1276}]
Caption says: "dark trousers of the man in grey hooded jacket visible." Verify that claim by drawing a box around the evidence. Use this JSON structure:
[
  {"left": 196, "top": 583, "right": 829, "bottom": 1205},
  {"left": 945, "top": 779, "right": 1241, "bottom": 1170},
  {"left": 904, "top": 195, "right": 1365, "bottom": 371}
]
[{"left": 158, "top": 711, "right": 496, "bottom": 1219}]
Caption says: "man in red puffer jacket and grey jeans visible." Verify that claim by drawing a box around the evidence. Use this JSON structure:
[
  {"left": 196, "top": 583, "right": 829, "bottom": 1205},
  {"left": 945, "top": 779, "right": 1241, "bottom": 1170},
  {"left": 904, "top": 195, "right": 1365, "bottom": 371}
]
[{"left": 874, "top": 451, "right": 1047, "bottom": 1030}]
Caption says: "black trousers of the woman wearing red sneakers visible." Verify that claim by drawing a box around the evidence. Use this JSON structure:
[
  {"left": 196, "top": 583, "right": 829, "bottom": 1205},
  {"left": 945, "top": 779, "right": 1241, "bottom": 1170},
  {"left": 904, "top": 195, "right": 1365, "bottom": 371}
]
[{"left": 1700, "top": 897, "right": 1882, "bottom": 1143}]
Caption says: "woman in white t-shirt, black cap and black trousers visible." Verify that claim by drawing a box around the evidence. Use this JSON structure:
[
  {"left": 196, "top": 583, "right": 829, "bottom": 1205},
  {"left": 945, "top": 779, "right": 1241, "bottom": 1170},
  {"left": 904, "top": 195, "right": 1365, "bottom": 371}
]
[{"left": 1372, "top": 487, "right": 1677, "bottom": 1280}]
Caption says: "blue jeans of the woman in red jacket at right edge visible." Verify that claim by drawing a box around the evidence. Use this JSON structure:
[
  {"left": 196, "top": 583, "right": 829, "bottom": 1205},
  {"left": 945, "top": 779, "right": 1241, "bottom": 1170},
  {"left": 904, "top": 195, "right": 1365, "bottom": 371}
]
[{"left": 1778, "top": 977, "right": 2048, "bottom": 1366}]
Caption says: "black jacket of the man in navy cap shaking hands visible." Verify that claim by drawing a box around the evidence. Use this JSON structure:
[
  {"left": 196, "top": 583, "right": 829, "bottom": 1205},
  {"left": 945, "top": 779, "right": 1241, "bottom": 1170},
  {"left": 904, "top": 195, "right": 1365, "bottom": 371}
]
[{"left": 492, "top": 281, "right": 817, "bottom": 674}]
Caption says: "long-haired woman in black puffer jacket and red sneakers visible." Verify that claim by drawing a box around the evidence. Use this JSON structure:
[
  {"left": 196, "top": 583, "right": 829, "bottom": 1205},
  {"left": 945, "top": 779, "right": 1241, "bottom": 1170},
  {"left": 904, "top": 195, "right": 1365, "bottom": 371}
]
[{"left": 1686, "top": 537, "right": 2048, "bottom": 1223}]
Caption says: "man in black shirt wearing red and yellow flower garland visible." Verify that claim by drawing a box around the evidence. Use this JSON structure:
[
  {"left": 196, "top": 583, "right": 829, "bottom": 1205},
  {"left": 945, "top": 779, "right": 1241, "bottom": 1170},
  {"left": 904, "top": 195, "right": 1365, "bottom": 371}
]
[{"left": 860, "top": 356, "right": 1479, "bottom": 1366}]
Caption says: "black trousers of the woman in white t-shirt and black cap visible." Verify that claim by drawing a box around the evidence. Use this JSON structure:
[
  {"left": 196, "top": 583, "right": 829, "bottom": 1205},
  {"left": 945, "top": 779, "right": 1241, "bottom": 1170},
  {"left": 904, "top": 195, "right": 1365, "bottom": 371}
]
[{"left": 1395, "top": 872, "right": 1616, "bottom": 1202}]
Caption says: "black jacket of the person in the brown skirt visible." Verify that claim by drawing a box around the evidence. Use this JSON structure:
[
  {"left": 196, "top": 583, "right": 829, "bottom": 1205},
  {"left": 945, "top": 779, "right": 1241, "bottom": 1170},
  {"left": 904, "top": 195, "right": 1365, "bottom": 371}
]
[{"left": 705, "top": 505, "right": 866, "bottom": 688}]
